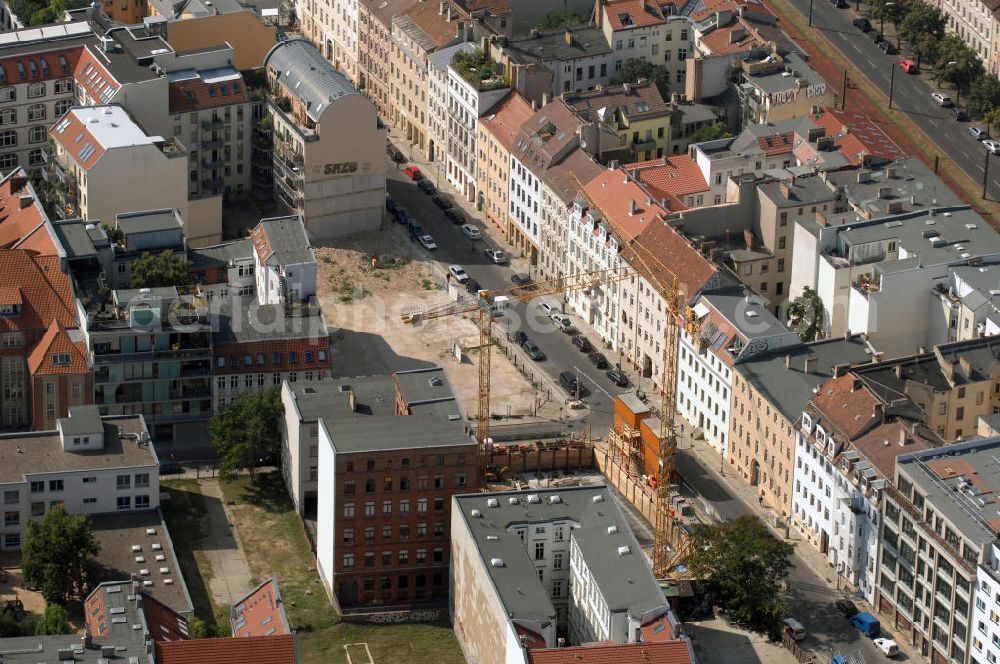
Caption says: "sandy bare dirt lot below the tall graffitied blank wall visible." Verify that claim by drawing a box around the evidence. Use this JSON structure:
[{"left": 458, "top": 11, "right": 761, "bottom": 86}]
[{"left": 315, "top": 227, "right": 561, "bottom": 419}]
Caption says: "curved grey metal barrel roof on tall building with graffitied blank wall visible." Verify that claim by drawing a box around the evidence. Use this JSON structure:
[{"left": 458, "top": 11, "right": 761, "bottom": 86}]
[{"left": 264, "top": 39, "right": 358, "bottom": 122}]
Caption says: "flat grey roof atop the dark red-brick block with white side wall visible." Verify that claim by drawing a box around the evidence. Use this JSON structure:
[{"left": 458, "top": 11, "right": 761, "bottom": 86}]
[{"left": 320, "top": 376, "right": 475, "bottom": 452}]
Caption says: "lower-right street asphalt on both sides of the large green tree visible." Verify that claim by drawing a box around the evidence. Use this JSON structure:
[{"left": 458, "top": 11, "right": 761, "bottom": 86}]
[{"left": 677, "top": 446, "right": 906, "bottom": 664}]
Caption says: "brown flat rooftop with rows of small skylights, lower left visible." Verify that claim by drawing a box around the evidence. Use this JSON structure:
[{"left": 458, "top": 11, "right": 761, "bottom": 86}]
[{"left": 91, "top": 509, "right": 194, "bottom": 615}]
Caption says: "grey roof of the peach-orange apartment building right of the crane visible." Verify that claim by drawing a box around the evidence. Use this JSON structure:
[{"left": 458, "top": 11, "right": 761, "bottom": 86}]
[{"left": 735, "top": 335, "right": 871, "bottom": 422}]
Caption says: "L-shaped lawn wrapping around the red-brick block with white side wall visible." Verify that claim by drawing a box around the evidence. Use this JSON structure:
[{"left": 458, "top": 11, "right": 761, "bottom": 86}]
[{"left": 219, "top": 473, "right": 465, "bottom": 664}]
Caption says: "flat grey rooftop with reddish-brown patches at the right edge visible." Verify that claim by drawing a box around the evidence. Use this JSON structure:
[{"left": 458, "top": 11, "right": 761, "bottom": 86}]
[{"left": 896, "top": 437, "right": 1000, "bottom": 545}]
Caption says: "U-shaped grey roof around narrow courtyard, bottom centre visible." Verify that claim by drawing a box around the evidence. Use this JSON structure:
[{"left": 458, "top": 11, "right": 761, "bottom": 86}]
[{"left": 452, "top": 485, "right": 666, "bottom": 621}]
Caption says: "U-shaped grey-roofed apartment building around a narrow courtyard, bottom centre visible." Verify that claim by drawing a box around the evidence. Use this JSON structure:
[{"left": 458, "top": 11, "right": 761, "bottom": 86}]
[{"left": 449, "top": 486, "right": 693, "bottom": 664}]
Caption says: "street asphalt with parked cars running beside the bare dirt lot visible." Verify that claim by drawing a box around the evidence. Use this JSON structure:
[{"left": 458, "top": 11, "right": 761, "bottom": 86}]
[{"left": 388, "top": 168, "right": 634, "bottom": 437}]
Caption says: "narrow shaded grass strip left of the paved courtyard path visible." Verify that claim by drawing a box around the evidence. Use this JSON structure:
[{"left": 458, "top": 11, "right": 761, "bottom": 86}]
[{"left": 160, "top": 479, "right": 229, "bottom": 636}]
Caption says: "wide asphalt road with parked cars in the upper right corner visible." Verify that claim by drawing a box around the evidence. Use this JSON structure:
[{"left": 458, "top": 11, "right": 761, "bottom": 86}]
[{"left": 792, "top": 0, "right": 1000, "bottom": 200}]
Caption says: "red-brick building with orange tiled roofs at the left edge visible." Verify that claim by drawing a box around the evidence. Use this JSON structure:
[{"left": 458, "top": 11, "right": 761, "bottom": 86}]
[{"left": 0, "top": 168, "right": 93, "bottom": 430}]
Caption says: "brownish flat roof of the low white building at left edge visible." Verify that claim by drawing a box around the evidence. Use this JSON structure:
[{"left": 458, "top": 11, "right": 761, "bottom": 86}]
[{"left": 0, "top": 415, "right": 159, "bottom": 484}]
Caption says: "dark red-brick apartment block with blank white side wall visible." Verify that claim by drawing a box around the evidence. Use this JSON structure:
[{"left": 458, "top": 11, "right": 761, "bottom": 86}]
[{"left": 311, "top": 367, "right": 478, "bottom": 607}]
